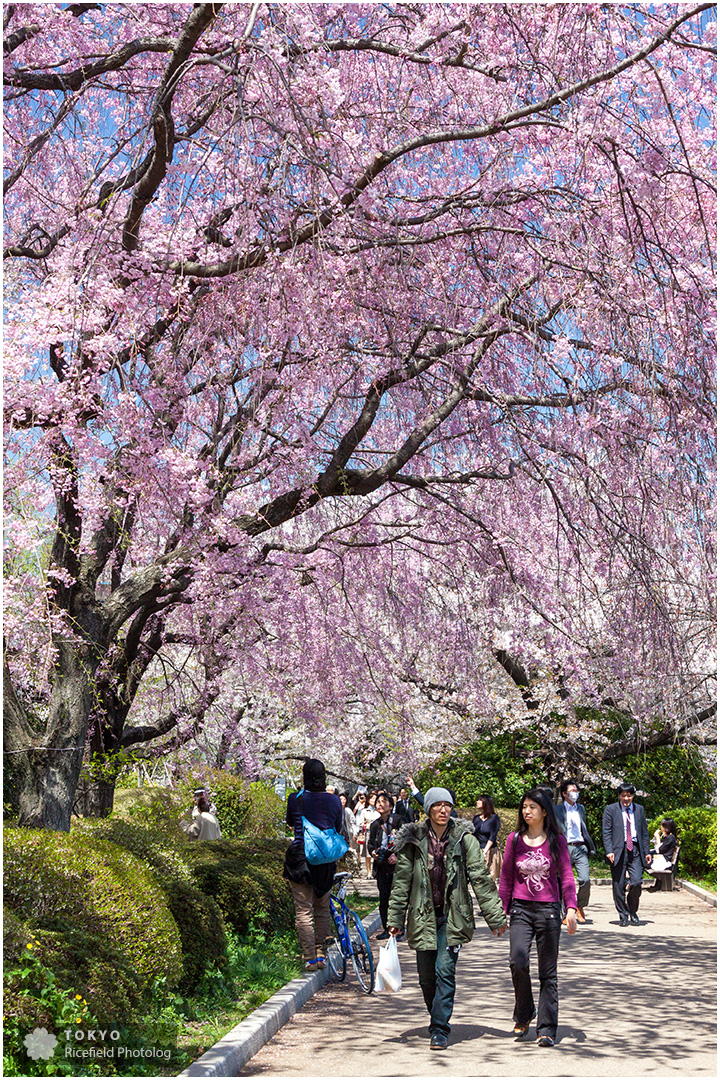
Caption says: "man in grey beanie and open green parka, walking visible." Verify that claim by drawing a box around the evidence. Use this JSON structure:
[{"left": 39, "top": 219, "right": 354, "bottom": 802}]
[{"left": 388, "top": 787, "right": 507, "bottom": 1050}]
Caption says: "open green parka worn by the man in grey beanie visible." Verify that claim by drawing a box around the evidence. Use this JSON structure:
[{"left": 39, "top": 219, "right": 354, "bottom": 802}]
[{"left": 388, "top": 818, "right": 506, "bottom": 949}]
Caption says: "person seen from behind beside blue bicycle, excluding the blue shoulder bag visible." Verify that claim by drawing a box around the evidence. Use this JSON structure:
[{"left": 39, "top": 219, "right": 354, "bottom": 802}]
[{"left": 283, "top": 758, "right": 343, "bottom": 971}]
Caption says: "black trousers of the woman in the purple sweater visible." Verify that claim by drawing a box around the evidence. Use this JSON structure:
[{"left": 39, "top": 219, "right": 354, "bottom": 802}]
[{"left": 510, "top": 900, "right": 562, "bottom": 1039}]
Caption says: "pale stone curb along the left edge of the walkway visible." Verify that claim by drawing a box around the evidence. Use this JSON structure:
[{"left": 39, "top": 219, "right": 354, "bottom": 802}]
[{"left": 178, "top": 909, "right": 380, "bottom": 1078}]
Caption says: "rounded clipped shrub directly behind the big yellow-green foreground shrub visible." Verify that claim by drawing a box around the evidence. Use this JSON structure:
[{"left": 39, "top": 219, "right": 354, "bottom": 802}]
[{"left": 78, "top": 816, "right": 228, "bottom": 989}]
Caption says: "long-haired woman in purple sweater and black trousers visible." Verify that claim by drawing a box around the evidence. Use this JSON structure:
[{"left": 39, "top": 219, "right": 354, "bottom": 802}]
[{"left": 499, "top": 787, "right": 578, "bottom": 1047}]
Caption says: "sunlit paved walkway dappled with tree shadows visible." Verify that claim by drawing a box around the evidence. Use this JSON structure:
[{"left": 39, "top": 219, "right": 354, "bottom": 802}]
[{"left": 239, "top": 882, "right": 718, "bottom": 1080}]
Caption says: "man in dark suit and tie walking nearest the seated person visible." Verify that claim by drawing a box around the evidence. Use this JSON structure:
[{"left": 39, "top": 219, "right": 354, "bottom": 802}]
[{"left": 602, "top": 784, "right": 652, "bottom": 927}]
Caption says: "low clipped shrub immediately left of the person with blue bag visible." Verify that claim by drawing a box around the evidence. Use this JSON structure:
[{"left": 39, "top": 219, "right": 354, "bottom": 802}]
[{"left": 188, "top": 839, "right": 295, "bottom": 935}]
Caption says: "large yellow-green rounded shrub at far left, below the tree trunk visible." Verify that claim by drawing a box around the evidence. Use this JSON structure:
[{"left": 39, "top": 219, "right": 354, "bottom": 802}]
[{"left": 3, "top": 828, "right": 182, "bottom": 986}]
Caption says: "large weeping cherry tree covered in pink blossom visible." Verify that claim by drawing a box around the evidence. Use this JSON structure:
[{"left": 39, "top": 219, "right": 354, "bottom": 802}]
[{"left": 3, "top": 3, "right": 716, "bottom": 828}]
